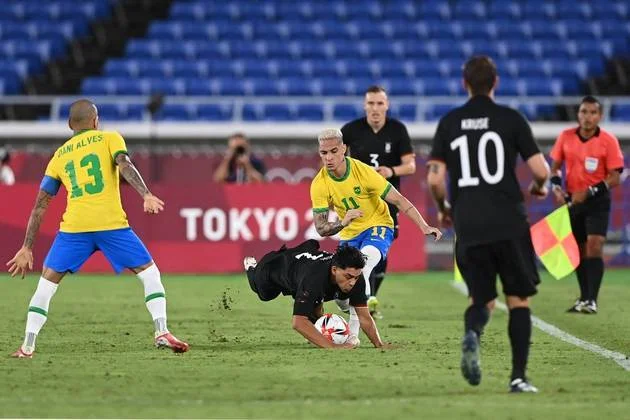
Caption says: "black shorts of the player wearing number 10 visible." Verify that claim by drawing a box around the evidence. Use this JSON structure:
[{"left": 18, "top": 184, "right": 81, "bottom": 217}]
[{"left": 455, "top": 231, "right": 540, "bottom": 304}]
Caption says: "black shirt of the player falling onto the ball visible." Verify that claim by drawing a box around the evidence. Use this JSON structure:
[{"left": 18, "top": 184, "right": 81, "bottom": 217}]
[{"left": 282, "top": 245, "right": 367, "bottom": 317}]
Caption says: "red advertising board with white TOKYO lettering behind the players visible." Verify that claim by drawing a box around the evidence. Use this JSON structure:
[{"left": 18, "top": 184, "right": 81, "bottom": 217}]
[{"left": 0, "top": 183, "right": 427, "bottom": 273}]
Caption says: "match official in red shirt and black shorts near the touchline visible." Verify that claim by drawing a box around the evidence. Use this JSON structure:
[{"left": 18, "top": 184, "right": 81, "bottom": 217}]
[{"left": 551, "top": 96, "right": 624, "bottom": 314}]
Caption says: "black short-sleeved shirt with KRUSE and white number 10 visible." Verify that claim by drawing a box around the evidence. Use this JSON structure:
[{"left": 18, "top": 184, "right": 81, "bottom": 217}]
[{"left": 430, "top": 95, "right": 540, "bottom": 244}]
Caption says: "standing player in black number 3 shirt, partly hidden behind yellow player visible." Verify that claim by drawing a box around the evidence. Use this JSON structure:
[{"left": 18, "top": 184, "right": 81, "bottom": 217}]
[{"left": 341, "top": 86, "right": 416, "bottom": 318}]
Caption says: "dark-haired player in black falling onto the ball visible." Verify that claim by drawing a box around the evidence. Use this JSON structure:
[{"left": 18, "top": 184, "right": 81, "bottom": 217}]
[{"left": 243, "top": 239, "right": 383, "bottom": 348}]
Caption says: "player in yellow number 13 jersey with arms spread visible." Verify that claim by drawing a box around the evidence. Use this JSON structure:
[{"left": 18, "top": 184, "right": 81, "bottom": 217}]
[{"left": 7, "top": 100, "right": 188, "bottom": 358}]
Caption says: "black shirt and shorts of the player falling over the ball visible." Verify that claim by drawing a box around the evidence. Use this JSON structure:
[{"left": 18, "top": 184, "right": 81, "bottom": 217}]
[{"left": 247, "top": 239, "right": 367, "bottom": 323}]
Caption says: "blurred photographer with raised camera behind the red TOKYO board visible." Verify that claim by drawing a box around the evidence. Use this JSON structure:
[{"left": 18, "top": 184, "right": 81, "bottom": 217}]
[{"left": 214, "top": 133, "right": 265, "bottom": 184}]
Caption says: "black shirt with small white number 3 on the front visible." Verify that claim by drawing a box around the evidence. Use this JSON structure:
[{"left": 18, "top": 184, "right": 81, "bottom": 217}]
[{"left": 341, "top": 117, "right": 413, "bottom": 189}]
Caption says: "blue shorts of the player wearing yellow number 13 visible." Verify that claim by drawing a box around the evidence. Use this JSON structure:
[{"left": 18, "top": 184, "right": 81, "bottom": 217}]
[{"left": 44, "top": 227, "right": 152, "bottom": 274}]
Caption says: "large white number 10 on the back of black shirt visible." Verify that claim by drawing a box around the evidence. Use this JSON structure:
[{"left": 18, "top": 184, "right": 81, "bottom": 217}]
[{"left": 451, "top": 131, "right": 505, "bottom": 187}]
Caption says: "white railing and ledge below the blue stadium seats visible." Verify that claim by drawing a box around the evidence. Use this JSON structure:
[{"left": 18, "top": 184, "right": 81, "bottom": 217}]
[{"left": 0, "top": 95, "right": 630, "bottom": 141}]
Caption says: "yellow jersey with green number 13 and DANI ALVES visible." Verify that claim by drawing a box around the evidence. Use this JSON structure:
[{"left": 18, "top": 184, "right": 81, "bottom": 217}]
[{"left": 46, "top": 130, "right": 129, "bottom": 233}]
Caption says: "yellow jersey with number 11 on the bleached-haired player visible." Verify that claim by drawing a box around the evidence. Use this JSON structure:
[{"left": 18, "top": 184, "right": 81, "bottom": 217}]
[{"left": 311, "top": 157, "right": 394, "bottom": 240}]
